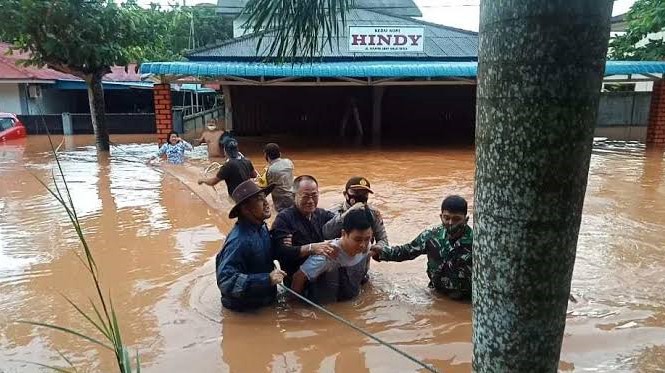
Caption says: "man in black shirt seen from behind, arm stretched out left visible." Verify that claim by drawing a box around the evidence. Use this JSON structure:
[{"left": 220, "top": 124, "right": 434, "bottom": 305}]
[{"left": 199, "top": 139, "right": 257, "bottom": 195}]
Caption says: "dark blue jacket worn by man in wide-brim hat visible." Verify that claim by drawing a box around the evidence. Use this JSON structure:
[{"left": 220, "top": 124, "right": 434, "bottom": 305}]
[{"left": 215, "top": 220, "right": 277, "bottom": 311}]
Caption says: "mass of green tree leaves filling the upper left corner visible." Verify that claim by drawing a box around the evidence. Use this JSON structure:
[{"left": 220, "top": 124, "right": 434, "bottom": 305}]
[{"left": 0, "top": 0, "right": 232, "bottom": 68}]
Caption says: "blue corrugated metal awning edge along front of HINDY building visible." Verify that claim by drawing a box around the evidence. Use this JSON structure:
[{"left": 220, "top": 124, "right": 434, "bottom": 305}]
[{"left": 140, "top": 61, "right": 665, "bottom": 78}]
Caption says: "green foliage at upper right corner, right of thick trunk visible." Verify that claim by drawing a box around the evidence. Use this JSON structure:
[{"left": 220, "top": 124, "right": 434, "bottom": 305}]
[{"left": 610, "top": 0, "right": 665, "bottom": 61}]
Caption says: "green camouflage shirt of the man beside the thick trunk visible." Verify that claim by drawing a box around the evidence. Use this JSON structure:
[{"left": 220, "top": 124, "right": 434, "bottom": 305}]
[{"left": 379, "top": 225, "right": 473, "bottom": 296}]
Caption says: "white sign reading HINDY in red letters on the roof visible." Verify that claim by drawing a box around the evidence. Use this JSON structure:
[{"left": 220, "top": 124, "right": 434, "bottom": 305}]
[{"left": 349, "top": 26, "right": 425, "bottom": 53}]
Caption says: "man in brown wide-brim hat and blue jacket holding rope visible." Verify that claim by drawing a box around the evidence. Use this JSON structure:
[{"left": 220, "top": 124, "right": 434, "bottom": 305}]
[{"left": 215, "top": 180, "right": 286, "bottom": 311}]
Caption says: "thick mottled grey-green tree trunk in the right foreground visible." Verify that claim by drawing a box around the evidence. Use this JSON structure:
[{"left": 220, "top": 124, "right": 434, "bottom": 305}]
[{"left": 473, "top": 0, "right": 612, "bottom": 373}]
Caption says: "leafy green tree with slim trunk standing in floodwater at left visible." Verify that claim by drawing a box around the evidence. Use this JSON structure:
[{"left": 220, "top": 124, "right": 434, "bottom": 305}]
[{"left": 0, "top": 0, "right": 160, "bottom": 151}]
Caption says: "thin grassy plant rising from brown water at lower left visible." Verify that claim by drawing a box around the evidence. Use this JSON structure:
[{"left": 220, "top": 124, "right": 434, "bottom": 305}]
[{"left": 18, "top": 134, "right": 141, "bottom": 373}]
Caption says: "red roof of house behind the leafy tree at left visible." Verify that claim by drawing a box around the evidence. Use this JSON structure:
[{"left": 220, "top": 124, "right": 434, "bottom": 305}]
[{"left": 0, "top": 42, "right": 141, "bottom": 82}]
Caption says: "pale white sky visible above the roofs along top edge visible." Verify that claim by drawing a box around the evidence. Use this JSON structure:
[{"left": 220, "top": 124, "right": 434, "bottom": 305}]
[{"left": 132, "top": 0, "right": 635, "bottom": 31}]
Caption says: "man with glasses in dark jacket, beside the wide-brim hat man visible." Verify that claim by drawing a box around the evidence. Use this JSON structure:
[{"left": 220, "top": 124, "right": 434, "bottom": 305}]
[{"left": 271, "top": 175, "right": 337, "bottom": 276}]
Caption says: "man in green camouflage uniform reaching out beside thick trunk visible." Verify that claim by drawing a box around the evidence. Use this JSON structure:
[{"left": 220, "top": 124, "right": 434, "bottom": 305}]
[{"left": 371, "top": 195, "right": 473, "bottom": 299}]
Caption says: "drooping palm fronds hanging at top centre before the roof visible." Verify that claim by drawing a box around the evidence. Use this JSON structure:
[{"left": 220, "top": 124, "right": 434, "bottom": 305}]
[{"left": 243, "top": 0, "right": 353, "bottom": 60}]
